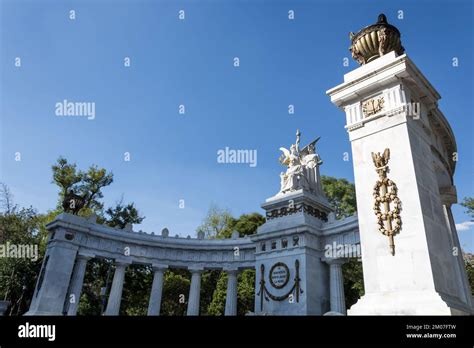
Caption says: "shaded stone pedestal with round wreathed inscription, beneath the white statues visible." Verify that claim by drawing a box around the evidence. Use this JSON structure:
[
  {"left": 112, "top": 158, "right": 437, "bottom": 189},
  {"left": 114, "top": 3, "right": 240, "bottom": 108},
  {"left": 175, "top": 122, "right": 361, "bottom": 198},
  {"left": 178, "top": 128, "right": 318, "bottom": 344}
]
[{"left": 252, "top": 190, "right": 331, "bottom": 315}]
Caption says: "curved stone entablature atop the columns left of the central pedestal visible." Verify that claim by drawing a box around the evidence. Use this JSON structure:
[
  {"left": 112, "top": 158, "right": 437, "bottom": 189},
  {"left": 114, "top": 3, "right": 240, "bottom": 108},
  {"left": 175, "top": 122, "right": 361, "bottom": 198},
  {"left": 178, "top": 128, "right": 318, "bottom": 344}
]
[{"left": 47, "top": 213, "right": 255, "bottom": 269}]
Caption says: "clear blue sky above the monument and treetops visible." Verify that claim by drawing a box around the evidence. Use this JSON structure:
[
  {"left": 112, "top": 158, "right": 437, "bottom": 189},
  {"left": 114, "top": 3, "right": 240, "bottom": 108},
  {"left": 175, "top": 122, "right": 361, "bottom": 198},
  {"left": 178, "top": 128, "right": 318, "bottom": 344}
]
[{"left": 0, "top": 0, "right": 474, "bottom": 251}]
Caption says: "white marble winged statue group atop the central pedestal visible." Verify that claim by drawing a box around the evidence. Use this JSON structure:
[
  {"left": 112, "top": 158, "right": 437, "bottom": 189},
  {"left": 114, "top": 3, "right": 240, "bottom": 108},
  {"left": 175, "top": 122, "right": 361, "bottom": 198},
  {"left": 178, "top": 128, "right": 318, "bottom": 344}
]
[{"left": 279, "top": 130, "right": 323, "bottom": 194}]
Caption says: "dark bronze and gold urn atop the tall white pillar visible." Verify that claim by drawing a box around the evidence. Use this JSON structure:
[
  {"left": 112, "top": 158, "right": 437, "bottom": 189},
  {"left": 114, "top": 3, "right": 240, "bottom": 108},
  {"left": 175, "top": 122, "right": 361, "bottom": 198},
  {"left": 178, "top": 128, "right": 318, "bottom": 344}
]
[{"left": 349, "top": 13, "right": 405, "bottom": 65}]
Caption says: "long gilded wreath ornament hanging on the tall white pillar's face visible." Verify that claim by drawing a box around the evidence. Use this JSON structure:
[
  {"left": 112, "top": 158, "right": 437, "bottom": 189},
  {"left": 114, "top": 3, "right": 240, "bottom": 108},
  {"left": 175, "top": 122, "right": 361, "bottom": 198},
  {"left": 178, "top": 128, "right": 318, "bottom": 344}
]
[{"left": 372, "top": 149, "right": 402, "bottom": 255}]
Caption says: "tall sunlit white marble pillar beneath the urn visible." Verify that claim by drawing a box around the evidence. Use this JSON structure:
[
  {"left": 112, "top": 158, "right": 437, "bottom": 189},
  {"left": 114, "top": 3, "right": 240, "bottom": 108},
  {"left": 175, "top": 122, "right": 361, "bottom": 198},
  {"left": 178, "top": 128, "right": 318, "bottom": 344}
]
[{"left": 327, "top": 51, "right": 471, "bottom": 315}]
